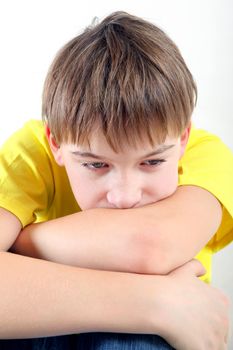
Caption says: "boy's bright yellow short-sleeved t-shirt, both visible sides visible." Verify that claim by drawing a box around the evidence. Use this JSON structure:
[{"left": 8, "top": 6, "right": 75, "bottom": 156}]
[{"left": 0, "top": 120, "right": 233, "bottom": 282}]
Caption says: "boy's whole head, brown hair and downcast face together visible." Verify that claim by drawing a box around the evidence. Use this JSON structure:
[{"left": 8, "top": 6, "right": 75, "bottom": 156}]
[{"left": 43, "top": 12, "right": 197, "bottom": 209}]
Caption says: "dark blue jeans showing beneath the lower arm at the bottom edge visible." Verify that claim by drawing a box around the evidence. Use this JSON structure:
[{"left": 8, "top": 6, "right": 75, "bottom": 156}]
[{"left": 0, "top": 333, "right": 173, "bottom": 350}]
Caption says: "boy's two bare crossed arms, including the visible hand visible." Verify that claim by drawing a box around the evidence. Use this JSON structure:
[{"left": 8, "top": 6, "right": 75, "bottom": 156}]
[{"left": 0, "top": 186, "right": 229, "bottom": 350}]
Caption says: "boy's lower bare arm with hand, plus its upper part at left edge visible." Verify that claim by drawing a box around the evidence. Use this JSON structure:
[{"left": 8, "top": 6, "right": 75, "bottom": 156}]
[{"left": 0, "top": 208, "right": 229, "bottom": 350}]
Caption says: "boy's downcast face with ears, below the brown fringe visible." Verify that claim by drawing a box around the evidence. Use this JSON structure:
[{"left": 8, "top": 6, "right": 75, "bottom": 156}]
[{"left": 46, "top": 128, "right": 189, "bottom": 210}]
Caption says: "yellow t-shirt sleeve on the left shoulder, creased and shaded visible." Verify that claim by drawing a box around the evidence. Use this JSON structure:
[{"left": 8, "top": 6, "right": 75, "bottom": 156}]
[{"left": 0, "top": 123, "right": 54, "bottom": 227}]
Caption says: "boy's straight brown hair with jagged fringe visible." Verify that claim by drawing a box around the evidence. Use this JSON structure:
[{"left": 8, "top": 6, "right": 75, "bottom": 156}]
[{"left": 42, "top": 12, "right": 197, "bottom": 150}]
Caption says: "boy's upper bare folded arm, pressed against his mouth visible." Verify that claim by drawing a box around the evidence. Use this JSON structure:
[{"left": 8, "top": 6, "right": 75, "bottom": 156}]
[{"left": 12, "top": 186, "right": 221, "bottom": 274}]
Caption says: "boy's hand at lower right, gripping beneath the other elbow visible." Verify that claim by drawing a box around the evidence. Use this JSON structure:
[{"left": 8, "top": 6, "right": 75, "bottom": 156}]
[{"left": 155, "top": 260, "right": 229, "bottom": 350}]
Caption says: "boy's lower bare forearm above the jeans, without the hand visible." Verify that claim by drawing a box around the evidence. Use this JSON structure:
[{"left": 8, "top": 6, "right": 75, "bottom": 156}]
[{"left": 0, "top": 253, "right": 160, "bottom": 339}]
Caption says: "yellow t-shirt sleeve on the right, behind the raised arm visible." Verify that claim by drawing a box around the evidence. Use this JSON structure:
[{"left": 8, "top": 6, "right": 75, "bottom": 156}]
[{"left": 179, "top": 128, "right": 233, "bottom": 252}]
